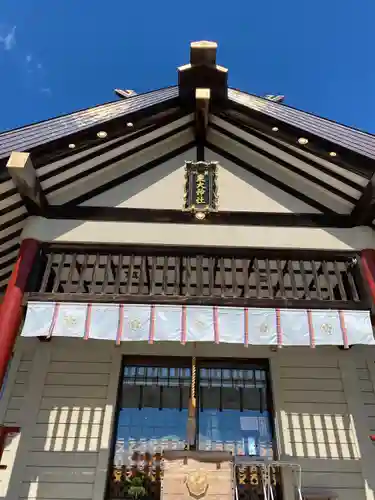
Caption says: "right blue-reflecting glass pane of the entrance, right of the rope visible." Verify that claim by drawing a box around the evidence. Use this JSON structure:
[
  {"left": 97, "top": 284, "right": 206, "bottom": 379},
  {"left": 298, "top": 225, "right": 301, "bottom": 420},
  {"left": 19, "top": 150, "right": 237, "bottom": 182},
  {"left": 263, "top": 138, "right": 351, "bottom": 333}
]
[{"left": 198, "top": 368, "right": 273, "bottom": 458}]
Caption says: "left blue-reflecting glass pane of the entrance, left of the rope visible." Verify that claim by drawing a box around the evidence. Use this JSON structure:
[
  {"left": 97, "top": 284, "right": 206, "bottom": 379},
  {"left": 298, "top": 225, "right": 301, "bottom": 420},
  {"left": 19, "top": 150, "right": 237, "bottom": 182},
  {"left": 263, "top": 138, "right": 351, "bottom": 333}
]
[{"left": 114, "top": 366, "right": 191, "bottom": 467}]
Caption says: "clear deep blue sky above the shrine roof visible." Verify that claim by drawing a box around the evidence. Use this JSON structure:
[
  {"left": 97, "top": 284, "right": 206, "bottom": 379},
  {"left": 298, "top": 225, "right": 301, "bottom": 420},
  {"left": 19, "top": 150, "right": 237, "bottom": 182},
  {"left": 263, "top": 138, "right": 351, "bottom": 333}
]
[{"left": 0, "top": 0, "right": 375, "bottom": 133}]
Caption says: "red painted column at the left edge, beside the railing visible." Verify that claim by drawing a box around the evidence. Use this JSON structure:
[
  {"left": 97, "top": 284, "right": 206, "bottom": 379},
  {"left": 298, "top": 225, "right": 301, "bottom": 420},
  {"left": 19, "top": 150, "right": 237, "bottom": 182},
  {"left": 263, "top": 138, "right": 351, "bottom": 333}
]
[{"left": 0, "top": 239, "right": 39, "bottom": 386}]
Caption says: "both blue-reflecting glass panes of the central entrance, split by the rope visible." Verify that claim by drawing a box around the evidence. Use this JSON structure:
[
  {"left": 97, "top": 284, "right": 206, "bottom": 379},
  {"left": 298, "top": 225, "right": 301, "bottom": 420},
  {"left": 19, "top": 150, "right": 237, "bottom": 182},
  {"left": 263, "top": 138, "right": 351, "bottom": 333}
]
[{"left": 113, "top": 363, "right": 273, "bottom": 467}]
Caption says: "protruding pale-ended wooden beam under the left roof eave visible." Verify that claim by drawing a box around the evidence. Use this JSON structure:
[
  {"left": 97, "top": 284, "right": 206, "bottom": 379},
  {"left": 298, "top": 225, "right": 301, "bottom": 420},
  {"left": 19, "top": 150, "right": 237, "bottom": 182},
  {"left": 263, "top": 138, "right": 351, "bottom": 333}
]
[{"left": 7, "top": 151, "right": 48, "bottom": 215}]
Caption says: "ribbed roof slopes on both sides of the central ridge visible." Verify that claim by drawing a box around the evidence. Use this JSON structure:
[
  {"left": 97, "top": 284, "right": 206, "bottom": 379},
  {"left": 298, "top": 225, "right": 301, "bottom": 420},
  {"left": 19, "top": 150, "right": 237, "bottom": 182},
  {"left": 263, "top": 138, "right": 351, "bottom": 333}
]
[{"left": 0, "top": 86, "right": 375, "bottom": 159}]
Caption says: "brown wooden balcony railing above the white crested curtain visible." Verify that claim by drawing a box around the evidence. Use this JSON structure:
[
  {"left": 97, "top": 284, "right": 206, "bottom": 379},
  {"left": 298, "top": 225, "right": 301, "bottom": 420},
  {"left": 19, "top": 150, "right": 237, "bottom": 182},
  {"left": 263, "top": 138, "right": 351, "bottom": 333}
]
[{"left": 28, "top": 245, "right": 370, "bottom": 309}]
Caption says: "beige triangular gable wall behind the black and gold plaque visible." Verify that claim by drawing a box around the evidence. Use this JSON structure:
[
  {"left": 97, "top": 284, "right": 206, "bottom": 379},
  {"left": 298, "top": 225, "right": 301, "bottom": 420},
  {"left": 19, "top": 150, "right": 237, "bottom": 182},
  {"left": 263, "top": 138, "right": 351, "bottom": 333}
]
[{"left": 83, "top": 148, "right": 318, "bottom": 213}]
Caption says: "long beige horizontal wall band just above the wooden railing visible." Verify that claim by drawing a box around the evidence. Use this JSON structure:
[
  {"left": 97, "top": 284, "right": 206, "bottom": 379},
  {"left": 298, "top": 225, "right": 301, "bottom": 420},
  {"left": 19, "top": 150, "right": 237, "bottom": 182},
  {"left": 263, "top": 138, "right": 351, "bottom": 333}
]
[{"left": 22, "top": 217, "right": 375, "bottom": 250}]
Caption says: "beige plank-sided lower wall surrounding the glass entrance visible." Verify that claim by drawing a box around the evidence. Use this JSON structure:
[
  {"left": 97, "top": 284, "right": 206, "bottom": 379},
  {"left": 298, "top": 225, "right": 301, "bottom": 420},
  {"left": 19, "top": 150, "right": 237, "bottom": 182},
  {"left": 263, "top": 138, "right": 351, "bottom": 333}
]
[{"left": 0, "top": 339, "right": 375, "bottom": 500}]
